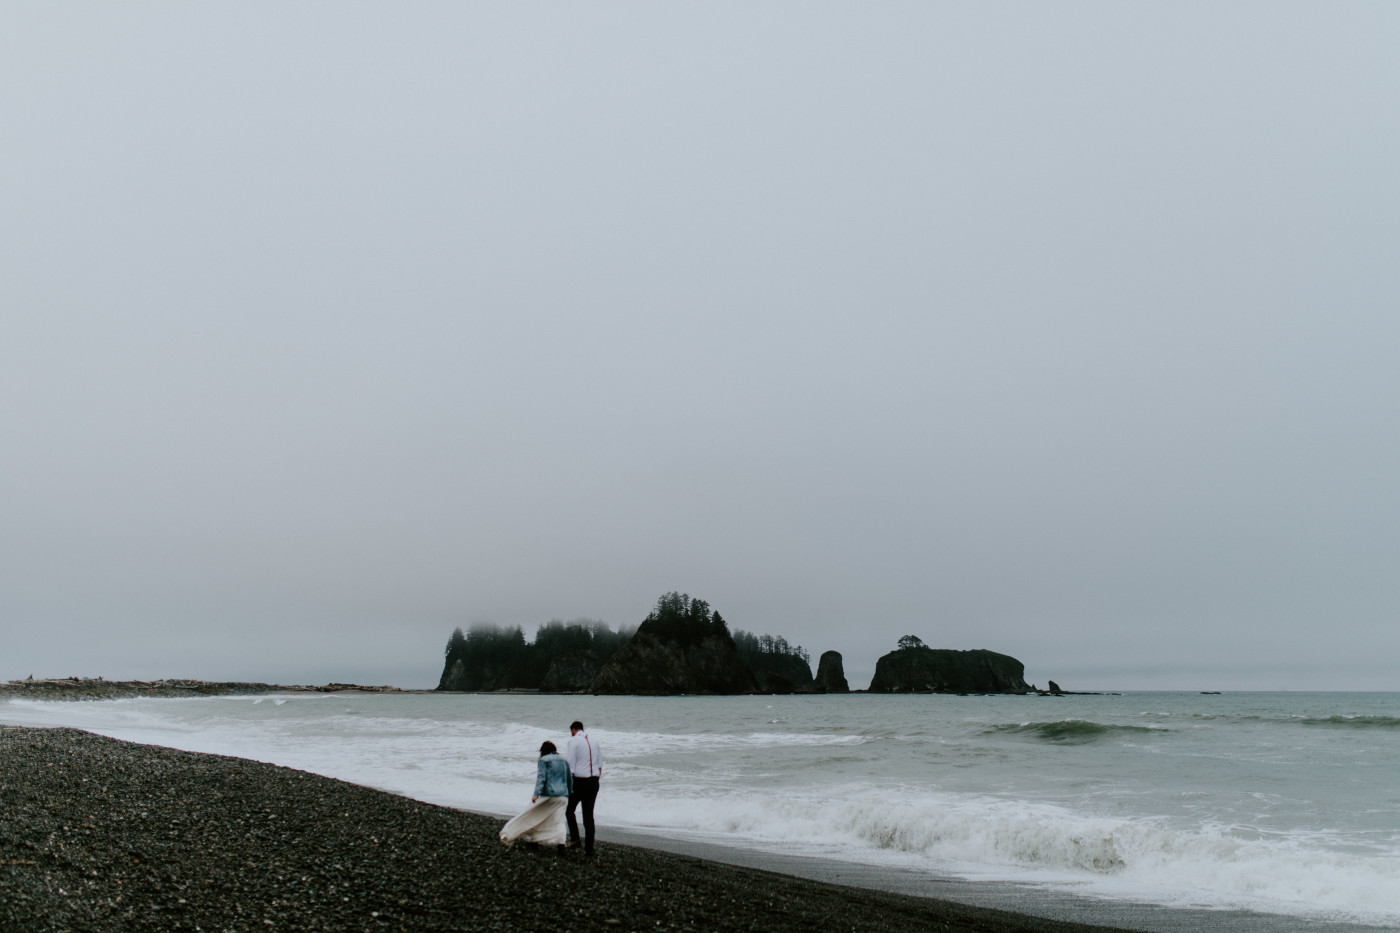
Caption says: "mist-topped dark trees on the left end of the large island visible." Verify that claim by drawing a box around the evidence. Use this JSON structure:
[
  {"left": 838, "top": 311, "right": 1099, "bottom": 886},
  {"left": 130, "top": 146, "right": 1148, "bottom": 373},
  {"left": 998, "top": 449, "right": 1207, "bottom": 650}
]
[{"left": 445, "top": 619, "right": 633, "bottom": 691}]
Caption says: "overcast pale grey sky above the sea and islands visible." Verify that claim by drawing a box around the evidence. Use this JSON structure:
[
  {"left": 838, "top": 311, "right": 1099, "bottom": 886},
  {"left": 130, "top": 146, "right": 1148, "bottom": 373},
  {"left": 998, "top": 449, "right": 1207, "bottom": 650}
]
[{"left": 0, "top": 0, "right": 1400, "bottom": 689}]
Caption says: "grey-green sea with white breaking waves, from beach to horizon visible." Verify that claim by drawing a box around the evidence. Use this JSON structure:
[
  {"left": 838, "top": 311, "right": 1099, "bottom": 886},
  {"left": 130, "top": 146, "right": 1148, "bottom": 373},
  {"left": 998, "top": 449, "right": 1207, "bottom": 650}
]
[{"left": 0, "top": 693, "right": 1400, "bottom": 929}]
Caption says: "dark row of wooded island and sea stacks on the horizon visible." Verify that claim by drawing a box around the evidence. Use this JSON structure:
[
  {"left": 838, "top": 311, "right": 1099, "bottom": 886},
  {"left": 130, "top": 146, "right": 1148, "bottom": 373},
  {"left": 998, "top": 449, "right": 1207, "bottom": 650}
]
[{"left": 437, "top": 593, "right": 1065, "bottom": 696}]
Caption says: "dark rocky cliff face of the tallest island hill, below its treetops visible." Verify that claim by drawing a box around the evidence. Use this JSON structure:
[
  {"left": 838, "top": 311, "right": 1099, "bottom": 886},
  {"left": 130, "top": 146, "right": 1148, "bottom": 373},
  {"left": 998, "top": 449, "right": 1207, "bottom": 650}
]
[{"left": 589, "top": 619, "right": 759, "bottom": 695}]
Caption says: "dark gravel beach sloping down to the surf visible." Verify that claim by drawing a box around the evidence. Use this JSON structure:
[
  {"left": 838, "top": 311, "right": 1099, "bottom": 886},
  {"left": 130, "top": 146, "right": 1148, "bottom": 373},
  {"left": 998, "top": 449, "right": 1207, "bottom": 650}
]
[{"left": 0, "top": 726, "right": 1136, "bottom": 933}]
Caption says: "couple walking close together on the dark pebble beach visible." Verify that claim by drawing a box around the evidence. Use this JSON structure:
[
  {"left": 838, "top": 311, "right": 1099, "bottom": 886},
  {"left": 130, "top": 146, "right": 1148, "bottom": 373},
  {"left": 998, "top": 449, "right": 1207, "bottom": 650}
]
[{"left": 501, "top": 720, "right": 603, "bottom": 855}]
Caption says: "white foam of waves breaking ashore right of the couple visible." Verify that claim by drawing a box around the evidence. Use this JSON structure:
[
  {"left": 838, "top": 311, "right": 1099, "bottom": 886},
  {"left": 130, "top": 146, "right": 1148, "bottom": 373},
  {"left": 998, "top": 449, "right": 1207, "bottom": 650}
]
[{"left": 599, "top": 786, "right": 1400, "bottom": 923}]
